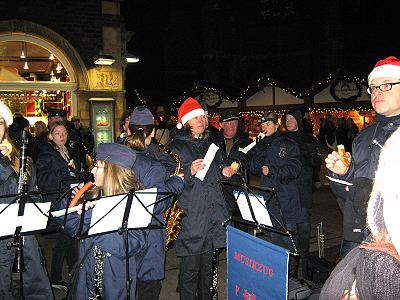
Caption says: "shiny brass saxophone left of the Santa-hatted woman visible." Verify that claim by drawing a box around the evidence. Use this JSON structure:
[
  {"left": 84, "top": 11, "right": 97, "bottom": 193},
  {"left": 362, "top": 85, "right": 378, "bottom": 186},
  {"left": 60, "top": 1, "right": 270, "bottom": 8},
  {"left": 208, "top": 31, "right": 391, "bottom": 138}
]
[{"left": 158, "top": 143, "right": 184, "bottom": 251}]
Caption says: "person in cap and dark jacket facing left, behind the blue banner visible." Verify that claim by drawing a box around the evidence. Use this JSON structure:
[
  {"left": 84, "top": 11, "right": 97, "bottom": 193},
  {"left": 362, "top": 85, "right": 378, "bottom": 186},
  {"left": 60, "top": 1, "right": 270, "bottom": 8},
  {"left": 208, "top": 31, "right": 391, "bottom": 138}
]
[{"left": 249, "top": 112, "right": 301, "bottom": 250}]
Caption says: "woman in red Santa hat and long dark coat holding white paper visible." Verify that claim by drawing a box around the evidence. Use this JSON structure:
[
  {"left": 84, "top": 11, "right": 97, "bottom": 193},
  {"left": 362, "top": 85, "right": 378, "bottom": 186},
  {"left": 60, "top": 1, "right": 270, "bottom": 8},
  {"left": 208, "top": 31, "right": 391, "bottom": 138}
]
[{"left": 163, "top": 98, "right": 235, "bottom": 300}]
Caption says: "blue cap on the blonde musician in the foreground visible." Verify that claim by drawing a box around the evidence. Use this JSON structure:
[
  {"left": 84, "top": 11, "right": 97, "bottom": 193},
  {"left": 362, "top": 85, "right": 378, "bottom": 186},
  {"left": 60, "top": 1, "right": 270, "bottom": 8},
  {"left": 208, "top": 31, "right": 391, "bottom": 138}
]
[{"left": 96, "top": 143, "right": 136, "bottom": 169}]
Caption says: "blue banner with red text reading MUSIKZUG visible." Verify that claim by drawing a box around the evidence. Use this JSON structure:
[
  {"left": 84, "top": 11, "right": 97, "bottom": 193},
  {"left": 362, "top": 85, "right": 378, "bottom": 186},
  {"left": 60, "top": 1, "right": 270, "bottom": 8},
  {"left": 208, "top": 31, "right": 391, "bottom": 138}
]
[{"left": 227, "top": 226, "right": 289, "bottom": 300}]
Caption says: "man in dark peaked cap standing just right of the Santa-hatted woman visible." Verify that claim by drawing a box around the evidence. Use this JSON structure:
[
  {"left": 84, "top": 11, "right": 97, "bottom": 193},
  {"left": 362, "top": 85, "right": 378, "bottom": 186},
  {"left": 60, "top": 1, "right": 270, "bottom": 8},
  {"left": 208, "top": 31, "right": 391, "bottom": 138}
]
[{"left": 211, "top": 108, "right": 253, "bottom": 231}]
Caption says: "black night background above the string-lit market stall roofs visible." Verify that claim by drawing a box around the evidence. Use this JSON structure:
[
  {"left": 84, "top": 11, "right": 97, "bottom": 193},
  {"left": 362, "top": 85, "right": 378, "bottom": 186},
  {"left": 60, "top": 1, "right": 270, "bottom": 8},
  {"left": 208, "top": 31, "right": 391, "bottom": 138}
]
[{"left": 121, "top": 0, "right": 400, "bottom": 106}]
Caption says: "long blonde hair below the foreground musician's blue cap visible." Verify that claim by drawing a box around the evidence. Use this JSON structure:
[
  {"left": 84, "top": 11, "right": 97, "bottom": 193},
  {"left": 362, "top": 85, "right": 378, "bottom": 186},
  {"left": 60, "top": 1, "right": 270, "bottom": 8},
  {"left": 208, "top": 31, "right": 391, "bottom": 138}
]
[{"left": 94, "top": 161, "right": 143, "bottom": 196}]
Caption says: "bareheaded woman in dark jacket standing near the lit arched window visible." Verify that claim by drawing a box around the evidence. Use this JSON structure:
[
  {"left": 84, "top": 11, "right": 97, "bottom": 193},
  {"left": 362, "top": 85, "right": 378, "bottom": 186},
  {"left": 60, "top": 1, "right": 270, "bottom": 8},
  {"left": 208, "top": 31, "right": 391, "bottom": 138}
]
[{"left": 36, "top": 121, "right": 78, "bottom": 288}]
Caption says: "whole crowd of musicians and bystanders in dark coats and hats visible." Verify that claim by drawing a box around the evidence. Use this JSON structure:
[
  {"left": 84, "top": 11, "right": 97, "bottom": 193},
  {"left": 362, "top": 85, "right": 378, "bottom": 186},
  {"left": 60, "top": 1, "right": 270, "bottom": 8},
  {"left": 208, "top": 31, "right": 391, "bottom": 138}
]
[{"left": 0, "top": 57, "right": 400, "bottom": 300}]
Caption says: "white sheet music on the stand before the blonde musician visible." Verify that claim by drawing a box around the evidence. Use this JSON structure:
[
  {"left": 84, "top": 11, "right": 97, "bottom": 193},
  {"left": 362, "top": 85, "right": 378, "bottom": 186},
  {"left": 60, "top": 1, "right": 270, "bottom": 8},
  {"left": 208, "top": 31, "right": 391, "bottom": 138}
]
[{"left": 88, "top": 188, "right": 157, "bottom": 235}]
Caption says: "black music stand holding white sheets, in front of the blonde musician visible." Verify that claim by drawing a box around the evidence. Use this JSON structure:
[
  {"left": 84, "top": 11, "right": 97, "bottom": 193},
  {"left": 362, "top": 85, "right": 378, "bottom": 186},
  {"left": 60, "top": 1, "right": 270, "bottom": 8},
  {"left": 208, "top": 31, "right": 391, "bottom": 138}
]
[{"left": 51, "top": 188, "right": 176, "bottom": 299}]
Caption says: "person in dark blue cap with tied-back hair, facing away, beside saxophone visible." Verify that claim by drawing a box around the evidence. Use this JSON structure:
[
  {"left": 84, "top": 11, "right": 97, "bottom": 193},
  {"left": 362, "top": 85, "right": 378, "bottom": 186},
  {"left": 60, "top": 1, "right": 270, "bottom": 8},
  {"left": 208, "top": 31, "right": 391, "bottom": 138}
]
[{"left": 125, "top": 106, "right": 184, "bottom": 300}]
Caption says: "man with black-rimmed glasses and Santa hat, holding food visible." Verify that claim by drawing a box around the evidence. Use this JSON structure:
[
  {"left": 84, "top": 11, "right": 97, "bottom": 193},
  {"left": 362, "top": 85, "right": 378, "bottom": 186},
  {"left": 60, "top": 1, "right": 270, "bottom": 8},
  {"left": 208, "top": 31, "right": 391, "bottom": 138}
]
[{"left": 325, "top": 56, "right": 400, "bottom": 257}]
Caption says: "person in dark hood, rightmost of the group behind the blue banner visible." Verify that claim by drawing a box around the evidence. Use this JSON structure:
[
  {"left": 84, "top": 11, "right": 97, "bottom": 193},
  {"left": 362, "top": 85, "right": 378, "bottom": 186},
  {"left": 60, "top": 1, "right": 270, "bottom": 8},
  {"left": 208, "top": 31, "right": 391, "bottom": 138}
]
[{"left": 282, "top": 110, "right": 322, "bottom": 276}]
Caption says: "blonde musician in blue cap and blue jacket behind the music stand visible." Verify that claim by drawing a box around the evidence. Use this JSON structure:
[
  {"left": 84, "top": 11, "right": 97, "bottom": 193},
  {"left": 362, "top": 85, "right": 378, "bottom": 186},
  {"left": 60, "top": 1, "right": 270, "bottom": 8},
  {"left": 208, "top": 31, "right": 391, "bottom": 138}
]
[{"left": 64, "top": 143, "right": 148, "bottom": 299}]
